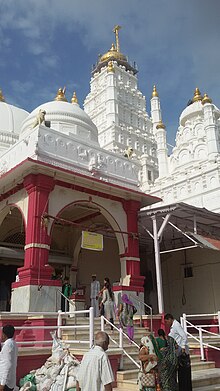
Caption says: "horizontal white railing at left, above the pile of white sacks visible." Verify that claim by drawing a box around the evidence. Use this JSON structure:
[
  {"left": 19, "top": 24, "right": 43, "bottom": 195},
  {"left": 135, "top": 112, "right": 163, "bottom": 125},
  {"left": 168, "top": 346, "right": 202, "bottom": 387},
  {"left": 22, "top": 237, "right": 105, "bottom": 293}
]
[{"left": 0, "top": 307, "right": 94, "bottom": 347}]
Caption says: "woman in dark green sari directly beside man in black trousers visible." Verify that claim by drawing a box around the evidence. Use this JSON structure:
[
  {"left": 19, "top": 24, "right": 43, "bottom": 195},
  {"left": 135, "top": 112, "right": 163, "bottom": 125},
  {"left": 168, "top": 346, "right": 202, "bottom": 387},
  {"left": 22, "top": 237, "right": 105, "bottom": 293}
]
[{"left": 158, "top": 336, "right": 178, "bottom": 391}]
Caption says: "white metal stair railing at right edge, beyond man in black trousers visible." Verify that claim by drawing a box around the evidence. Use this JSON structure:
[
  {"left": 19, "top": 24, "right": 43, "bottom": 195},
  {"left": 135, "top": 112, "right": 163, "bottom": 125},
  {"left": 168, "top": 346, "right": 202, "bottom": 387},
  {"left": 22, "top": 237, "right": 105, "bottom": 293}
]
[{"left": 180, "top": 311, "right": 220, "bottom": 361}]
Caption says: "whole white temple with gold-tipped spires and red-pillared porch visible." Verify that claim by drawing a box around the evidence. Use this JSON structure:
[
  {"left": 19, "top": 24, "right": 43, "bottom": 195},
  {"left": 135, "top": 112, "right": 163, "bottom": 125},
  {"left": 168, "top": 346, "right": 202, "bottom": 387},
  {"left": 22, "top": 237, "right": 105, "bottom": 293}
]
[{"left": 0, "top": 26, "right": 220, "bottom": 312}]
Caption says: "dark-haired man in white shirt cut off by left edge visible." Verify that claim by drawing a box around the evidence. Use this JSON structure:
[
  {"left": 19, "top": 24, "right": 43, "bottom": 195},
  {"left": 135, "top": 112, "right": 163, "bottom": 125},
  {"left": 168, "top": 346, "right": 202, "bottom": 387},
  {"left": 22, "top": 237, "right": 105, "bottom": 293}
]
[{"left": 0, "top": 325, "right": 18, "bottom": 391}]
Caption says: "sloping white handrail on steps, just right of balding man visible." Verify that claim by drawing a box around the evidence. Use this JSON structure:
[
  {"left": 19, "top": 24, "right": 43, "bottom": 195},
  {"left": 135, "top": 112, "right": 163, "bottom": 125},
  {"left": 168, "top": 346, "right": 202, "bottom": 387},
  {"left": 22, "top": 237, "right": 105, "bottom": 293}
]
[{"left": 101, "top": 315, "right": 140, "bottom": 370}]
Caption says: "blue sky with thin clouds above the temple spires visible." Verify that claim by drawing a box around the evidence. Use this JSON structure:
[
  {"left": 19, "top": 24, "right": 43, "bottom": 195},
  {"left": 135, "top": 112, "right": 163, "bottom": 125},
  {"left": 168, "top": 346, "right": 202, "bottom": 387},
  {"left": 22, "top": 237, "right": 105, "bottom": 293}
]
[{"left": 0, "top": 0, "right": 220, "bottom": 144}]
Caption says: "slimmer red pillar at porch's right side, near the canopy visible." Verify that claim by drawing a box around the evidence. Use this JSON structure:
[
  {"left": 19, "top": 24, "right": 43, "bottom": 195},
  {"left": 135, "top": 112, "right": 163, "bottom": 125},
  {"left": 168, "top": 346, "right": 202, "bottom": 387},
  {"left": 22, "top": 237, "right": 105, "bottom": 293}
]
[{"left": 121, "top": 200, "right": 144, "bottom": 290}]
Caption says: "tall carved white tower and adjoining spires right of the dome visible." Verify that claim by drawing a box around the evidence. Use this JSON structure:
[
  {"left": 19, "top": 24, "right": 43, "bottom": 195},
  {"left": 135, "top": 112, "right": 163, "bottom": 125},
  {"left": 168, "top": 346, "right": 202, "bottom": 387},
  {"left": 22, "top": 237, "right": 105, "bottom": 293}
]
[{"left": 84, "top": 44, "right": 220, "bottom": 212}]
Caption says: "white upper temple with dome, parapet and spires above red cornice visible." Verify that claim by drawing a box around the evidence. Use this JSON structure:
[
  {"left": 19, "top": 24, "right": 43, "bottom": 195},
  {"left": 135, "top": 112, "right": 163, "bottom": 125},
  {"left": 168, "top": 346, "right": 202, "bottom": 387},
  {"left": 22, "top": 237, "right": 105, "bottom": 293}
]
[{"left": 0, "top": 34, "right": 220, "bottom": 212}]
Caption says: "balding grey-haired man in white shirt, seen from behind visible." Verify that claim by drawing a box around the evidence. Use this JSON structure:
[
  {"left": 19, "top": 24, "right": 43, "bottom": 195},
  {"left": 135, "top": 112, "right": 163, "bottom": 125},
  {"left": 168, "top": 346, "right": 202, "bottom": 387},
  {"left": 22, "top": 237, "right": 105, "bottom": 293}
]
[{"left": 76, "top": 331, "right": 114, "bottom": 391}]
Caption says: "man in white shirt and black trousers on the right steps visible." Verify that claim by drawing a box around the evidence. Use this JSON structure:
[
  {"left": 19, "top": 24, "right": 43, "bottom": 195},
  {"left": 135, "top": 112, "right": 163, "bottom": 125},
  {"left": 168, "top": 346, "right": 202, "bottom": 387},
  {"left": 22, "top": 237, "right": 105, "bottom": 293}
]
[{"left": 164, "top": 314, "right": 192, "bottom": 391}]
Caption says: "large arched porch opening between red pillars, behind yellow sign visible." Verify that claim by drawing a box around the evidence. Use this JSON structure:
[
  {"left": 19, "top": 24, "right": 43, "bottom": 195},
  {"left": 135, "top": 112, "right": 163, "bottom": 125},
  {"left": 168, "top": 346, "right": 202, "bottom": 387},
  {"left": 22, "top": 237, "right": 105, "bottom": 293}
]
[{"left": 50, "top": 201, "right": 123, "bottom": 305}]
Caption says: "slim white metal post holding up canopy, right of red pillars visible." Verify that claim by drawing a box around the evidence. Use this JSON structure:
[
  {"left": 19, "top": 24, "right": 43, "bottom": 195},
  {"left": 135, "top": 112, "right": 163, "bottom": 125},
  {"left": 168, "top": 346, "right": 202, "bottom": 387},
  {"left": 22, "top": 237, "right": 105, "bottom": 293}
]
[{"left": 152, "top": 216, "right": 164, "bottom": 314}]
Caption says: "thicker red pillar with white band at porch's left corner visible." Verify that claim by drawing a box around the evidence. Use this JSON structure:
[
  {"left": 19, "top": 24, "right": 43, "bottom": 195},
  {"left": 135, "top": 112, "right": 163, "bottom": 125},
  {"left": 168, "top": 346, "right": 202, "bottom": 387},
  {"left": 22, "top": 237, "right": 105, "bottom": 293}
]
[{"left": 13, "top": 174, "right": 57, "bottom": 287}]
